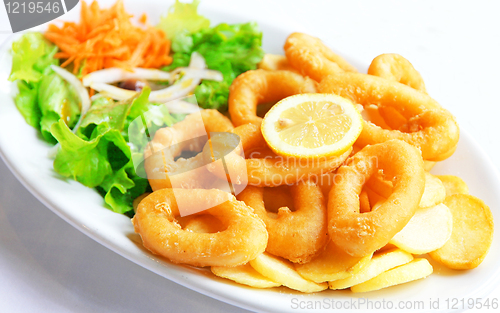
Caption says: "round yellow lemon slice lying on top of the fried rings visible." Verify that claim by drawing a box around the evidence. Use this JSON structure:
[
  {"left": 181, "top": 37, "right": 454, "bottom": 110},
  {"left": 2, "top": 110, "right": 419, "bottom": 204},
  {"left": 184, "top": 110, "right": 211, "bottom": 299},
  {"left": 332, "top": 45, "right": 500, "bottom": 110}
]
[{"left": 261, "top": 93, "right": 363, "bottom": 158}]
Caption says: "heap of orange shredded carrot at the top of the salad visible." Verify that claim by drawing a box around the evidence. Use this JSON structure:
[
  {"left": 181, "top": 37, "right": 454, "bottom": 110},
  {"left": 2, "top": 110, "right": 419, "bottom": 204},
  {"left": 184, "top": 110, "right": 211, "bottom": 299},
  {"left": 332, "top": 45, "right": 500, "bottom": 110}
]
[{"left": 45, "top": 0, "right": 172, "bottom": 75}]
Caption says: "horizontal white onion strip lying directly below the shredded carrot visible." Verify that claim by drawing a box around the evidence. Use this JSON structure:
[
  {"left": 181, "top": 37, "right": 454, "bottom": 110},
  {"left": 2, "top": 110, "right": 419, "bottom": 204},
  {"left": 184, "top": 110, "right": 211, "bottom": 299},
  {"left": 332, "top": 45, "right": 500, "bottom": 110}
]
[{"left": 82, "top": 67, "right": 173, "bottom": 87}]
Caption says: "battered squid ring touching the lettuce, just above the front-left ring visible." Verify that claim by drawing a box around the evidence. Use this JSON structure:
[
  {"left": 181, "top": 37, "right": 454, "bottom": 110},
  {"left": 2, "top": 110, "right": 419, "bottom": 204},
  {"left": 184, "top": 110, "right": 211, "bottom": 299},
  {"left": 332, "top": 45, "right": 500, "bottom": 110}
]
[{"left": 144, "top": 110, "right": 234, "bottom": 190}]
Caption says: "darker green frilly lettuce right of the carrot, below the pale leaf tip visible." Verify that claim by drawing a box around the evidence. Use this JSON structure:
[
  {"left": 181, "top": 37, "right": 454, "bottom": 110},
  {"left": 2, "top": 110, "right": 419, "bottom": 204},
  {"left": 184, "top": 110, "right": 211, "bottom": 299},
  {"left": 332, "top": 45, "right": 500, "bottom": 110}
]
[{"left": 164, "top": 22, "right": 264, "bottom": 111}]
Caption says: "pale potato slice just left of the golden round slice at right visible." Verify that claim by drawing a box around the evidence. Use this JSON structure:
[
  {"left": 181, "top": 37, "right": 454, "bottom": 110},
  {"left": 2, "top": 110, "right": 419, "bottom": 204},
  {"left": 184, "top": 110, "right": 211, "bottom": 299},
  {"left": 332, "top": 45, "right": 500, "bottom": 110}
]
[{"left": 389, "top": 203, "right": 453, "bottom": 254}]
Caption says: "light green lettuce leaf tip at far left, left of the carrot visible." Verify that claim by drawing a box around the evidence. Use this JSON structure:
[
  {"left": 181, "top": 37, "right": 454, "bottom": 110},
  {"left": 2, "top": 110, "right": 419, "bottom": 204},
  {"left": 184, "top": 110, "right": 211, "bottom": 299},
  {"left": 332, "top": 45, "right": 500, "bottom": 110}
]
[{"left": 9, "top": 32, "right": 59, "bottom": 82}]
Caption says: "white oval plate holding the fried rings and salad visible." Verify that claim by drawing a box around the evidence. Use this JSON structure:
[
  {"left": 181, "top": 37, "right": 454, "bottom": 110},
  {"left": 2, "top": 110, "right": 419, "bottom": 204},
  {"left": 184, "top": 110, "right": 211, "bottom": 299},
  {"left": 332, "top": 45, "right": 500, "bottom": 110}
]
[{"left": 0, "top": 1, "right": 500, "bottom": 312}]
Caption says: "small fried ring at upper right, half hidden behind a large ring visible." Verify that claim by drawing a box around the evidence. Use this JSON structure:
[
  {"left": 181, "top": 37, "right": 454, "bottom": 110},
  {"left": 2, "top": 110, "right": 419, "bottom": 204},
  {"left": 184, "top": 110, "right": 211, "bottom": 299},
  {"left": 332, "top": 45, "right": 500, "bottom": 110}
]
[{"left": 368, "top": 53, "right": 426, "bottom": 93}]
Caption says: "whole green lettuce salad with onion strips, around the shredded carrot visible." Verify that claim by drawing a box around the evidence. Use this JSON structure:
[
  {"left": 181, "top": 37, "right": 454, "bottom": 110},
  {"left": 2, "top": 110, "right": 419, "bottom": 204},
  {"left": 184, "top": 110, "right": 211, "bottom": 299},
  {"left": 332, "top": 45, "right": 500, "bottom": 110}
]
[{"left": 9, "top": 0, "right": 264, "bottom": 216}]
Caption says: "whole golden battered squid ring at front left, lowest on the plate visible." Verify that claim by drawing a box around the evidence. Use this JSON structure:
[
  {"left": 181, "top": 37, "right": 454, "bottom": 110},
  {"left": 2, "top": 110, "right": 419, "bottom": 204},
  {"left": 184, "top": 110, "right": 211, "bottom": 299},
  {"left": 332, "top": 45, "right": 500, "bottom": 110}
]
[{"left": 132, "top": 188, "right": 268, "bottom": 266}]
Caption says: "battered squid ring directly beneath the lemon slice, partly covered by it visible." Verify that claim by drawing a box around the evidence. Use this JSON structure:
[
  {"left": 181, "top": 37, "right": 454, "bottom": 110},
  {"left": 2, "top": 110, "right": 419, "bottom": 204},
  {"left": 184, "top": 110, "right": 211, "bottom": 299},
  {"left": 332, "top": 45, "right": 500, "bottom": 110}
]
[{"left": 203, "top": 124, "right": 352, "bottom": 187}]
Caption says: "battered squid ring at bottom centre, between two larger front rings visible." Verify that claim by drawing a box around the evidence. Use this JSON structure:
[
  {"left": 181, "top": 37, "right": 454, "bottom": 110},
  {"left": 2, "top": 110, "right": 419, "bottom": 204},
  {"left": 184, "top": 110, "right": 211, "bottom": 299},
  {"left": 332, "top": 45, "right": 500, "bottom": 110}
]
[{"left": 238, "top": 181, "right": 328, "bottom": 263}]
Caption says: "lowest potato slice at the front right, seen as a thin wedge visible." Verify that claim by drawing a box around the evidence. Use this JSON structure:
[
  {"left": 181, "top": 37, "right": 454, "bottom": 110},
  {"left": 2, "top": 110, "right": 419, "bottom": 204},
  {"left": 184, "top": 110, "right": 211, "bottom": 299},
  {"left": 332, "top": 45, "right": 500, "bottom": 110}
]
[{"left": 351, "top": 259, "right": 433, "bottom": 292}]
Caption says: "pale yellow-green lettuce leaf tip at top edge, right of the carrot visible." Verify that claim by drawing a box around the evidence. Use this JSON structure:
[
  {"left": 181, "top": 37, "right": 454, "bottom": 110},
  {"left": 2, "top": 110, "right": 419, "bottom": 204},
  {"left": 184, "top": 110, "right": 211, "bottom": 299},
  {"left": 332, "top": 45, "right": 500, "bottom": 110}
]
[{"left": 157, "top": 0, "right": 210, "bottom": 39}]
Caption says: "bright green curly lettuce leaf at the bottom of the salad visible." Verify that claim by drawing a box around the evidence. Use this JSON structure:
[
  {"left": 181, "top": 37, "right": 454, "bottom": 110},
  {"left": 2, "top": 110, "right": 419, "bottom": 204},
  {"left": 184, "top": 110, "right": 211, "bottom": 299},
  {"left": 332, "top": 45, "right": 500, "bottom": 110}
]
[{"left": 52, "top": 120, "right": 149, "bottom": 214}]
